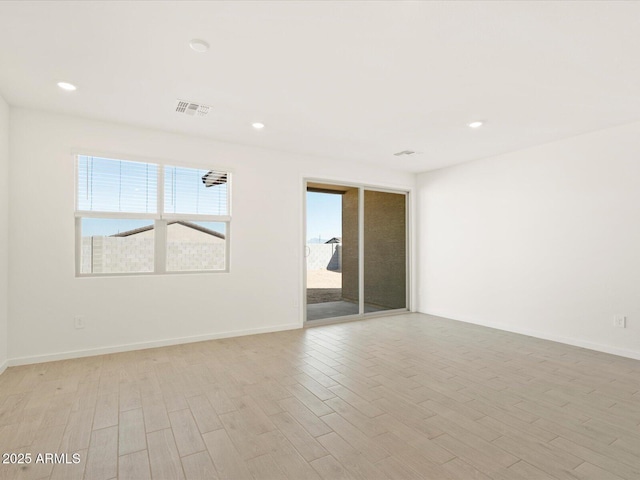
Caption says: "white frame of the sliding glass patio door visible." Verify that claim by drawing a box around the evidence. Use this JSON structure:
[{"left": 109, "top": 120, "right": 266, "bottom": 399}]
[{"left": 301, "top": 177, "right": 412, "bottom": 327}]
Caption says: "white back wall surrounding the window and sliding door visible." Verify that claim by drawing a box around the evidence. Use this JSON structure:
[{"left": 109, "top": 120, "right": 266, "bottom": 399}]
[{"left": 9, "top": 108, "right": 414, "bottom": 364}]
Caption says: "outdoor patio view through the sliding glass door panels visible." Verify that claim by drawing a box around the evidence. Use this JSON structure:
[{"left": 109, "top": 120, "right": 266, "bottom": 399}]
[{"left": 305, "top": 182, "right": 407, "bottom": 321}]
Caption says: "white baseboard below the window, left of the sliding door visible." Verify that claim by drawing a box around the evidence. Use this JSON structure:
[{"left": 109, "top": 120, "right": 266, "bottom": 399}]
[{"left": 7, "top": 323, "right": 301, "bottom": 373}]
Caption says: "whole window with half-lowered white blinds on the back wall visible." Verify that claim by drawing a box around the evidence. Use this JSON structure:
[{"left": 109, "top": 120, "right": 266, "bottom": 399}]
[{"left": 76, "top": 155, "right": 231, "bottom": 276}]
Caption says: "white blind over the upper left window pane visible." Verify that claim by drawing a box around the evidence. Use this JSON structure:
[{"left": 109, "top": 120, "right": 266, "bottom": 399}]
[{"left": 77, "top": 155, "right": 158, "bottom": 213}]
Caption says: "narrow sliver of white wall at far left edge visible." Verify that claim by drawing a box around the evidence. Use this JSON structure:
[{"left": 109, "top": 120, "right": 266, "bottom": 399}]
[{"left": 0, "top": 97, "right": 9, "bottom": 373}]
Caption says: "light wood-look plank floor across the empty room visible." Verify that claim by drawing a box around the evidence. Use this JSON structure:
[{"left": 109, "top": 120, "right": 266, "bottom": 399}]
[{"left": 0, "top": 314, "right": 640, "bottom": 480}]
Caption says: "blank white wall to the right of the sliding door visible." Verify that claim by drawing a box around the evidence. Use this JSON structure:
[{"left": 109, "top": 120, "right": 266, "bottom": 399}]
[{"left": 417, "top": 123, "right": 640, "bottom": 358}]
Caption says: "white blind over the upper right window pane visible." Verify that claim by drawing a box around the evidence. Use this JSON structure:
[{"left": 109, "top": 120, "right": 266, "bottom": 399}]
[{"left": 164, "top": 166, "right": 229, "bottom": 216}]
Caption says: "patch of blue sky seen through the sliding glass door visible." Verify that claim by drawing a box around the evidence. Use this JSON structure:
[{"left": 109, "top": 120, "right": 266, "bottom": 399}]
[{"left": 307, "top": 192, "right": 342, "bottom": 242}]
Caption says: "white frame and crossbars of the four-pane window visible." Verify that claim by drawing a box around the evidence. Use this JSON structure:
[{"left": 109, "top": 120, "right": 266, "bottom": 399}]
[{"left": 72, "top": 150, "right": 233, "bottom": 278}]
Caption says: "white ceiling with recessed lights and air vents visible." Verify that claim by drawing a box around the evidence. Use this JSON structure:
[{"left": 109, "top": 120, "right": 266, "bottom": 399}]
[{"left": 0, "top": 1, "right": 640, "bottom": 171}]
